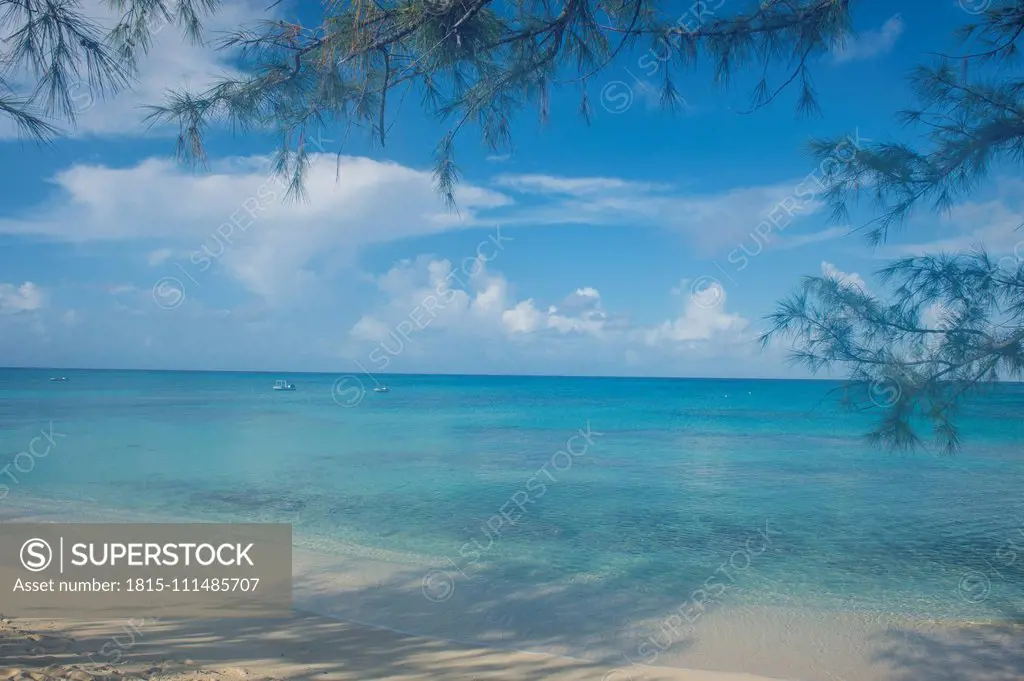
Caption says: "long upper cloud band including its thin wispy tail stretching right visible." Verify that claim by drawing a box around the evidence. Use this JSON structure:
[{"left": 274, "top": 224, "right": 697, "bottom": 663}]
[{"left": 0, "top": 154, "right": 831, "bottom": 311}]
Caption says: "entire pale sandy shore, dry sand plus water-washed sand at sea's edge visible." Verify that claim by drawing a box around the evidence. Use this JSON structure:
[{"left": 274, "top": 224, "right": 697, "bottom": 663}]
[{"left": 6, "top": 503, "right": 1024, "bottom": 681}]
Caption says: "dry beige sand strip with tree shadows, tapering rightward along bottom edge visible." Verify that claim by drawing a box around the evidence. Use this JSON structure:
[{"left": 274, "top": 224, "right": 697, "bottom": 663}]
[{"left": 0, "top": 612, "right": 790, "bottom": 681}]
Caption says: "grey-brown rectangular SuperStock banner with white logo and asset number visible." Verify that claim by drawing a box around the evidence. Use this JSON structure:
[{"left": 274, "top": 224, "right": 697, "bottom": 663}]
[{"left": 0, "top": 523, "right": 292, "bottom": 620}]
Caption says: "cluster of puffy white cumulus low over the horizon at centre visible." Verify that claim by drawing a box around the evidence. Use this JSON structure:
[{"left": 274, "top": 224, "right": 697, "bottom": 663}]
[{"left": 350, "top": 256, "right": 752, "bottom": 364}]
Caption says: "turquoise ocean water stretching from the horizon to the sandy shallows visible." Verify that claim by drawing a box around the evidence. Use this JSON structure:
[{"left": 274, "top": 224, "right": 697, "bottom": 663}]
[{"left": 0, "top": 370, "right": 1024, "bottom": 667}]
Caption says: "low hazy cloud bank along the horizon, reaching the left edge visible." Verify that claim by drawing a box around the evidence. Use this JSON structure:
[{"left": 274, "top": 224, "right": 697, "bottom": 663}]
[{"left": 0, "top": 256, "right": 779, "bottom": 376}]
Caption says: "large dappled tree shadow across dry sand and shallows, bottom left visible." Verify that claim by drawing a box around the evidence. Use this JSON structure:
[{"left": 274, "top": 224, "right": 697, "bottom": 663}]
[{"left": 0, "top": 552, "right": 712, "bottom": 681}]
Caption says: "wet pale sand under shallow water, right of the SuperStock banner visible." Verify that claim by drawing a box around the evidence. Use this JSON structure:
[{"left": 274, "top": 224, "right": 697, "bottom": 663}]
[{"left": 286, "top": 550, "right": 1024, "bottom": 681}]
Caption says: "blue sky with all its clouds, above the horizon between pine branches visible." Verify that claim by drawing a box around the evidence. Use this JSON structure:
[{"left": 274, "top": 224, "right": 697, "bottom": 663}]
[{"left": 0, "top": 0, "right": 1024, "bottom": 378}]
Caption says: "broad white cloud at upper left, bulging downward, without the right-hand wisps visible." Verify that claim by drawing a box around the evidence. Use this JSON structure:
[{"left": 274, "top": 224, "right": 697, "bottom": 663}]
[{"left": 0, "top": 155, "right": 510, "bottom": 302}]
